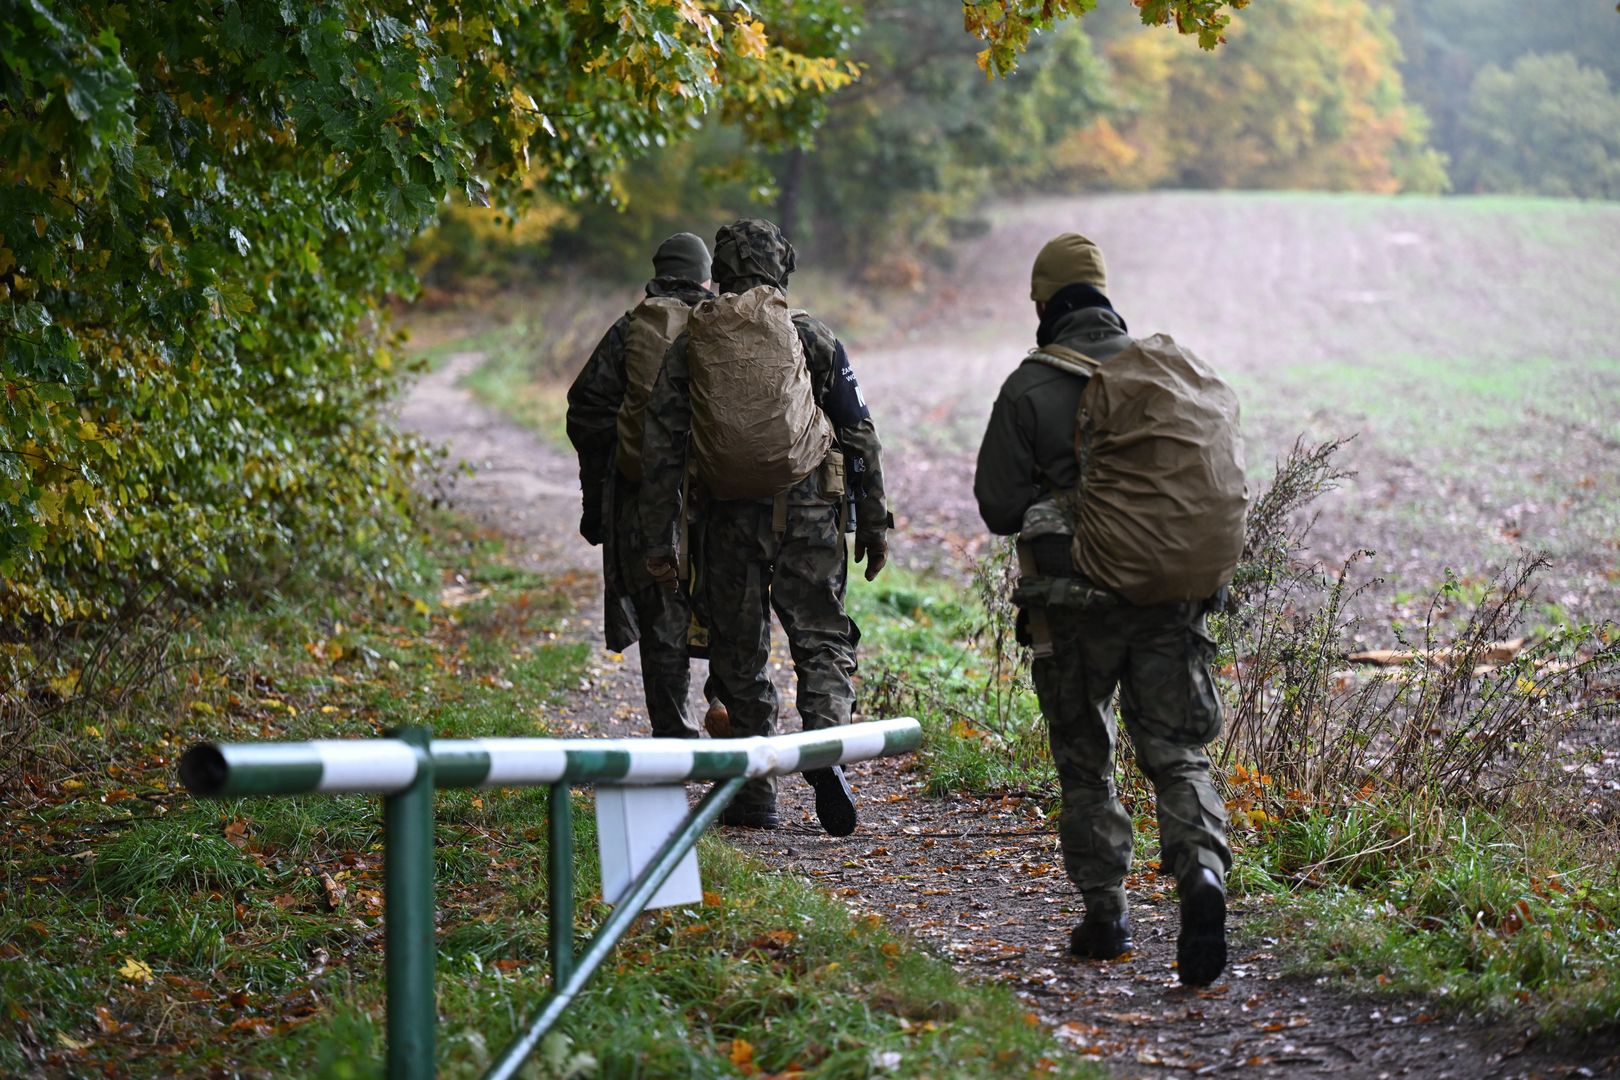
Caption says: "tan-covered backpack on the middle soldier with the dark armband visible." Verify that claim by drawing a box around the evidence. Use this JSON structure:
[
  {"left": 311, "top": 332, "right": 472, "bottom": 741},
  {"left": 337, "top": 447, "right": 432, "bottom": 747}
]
[{"left": 687, "top": 285, "right": 833, "bottom": 499}]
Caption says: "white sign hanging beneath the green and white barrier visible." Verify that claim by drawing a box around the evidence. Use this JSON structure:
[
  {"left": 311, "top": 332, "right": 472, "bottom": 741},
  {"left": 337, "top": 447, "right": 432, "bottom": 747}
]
[{"left": 596, "top": 784, "right": 703, "bottom": 907}]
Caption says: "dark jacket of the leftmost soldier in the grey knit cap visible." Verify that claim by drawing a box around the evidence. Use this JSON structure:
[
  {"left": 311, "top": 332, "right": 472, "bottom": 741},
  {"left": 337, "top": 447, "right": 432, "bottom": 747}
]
[{"left": 567, "top": 277, "right": 713, "bottom": 544}]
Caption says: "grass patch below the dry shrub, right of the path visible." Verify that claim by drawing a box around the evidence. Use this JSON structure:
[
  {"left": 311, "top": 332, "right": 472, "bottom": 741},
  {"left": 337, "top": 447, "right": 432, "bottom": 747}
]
[{"left": 1241, "top": 798, "right": 1620, "bottom": 1031}]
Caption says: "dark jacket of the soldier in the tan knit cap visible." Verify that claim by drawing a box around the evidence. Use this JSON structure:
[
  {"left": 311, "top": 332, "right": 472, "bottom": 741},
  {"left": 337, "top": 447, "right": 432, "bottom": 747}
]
[{"left": 974, "top": 308, "right": 1132, "bottom": 536}]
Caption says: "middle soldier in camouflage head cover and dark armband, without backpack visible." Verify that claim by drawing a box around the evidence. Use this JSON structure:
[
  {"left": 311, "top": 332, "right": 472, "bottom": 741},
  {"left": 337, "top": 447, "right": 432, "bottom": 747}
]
[{"left": 642, "top": 219, "right": 893, "bottom": 836}]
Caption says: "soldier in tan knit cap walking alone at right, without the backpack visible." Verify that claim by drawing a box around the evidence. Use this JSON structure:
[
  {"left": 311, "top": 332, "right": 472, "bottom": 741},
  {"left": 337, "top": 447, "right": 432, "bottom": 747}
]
[{"left": 974, "top": 233, "right": 1231, "bottom": 984}]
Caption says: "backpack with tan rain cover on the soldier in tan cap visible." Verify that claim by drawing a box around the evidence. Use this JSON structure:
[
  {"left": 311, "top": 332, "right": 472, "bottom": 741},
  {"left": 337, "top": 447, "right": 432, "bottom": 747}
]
[{"left": 1030, "top": 334, "right": 1249, "bottom": 604}]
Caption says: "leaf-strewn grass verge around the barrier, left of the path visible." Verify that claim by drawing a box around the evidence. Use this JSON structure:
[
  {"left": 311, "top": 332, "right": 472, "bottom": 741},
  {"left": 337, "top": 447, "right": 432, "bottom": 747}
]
[{"left": 0, "top": 526, "right": 1092, "bottom": 1077}]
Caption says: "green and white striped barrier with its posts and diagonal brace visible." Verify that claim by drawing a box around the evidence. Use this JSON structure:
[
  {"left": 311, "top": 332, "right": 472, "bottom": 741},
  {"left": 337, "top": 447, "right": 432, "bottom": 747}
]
[{"left": 180, "top": 717, "right": 922, "bottom": 1080}]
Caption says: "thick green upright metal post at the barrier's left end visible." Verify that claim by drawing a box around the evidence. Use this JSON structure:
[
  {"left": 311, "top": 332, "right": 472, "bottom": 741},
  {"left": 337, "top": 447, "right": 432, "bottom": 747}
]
[{"left": 382, "top": 727, "right": 439, "bottom": 1080}]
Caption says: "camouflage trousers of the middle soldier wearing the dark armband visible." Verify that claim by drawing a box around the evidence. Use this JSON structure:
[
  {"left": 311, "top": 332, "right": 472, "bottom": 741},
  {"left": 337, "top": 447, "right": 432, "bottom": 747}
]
[{"left": 697, "top": 473, "right": 860, "bottom": 803}]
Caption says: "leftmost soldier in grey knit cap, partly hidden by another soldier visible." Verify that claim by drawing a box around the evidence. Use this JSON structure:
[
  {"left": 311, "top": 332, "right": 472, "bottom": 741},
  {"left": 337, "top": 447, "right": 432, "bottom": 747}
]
[{"left": 567, "top": 233, "right": 724, "bottom": 738}]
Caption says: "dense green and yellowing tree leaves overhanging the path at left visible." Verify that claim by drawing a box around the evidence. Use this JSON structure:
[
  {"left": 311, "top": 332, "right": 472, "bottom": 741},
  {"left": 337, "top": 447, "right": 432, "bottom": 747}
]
[{"left": 0, "top": 0, "right": 852, "bottom": 627}]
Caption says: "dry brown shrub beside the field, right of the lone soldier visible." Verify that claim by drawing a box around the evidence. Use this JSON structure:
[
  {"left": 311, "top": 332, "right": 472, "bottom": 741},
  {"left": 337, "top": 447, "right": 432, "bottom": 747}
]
[{"left": 1215, "top": 440, "right": 1620, "bottom": 811}]
